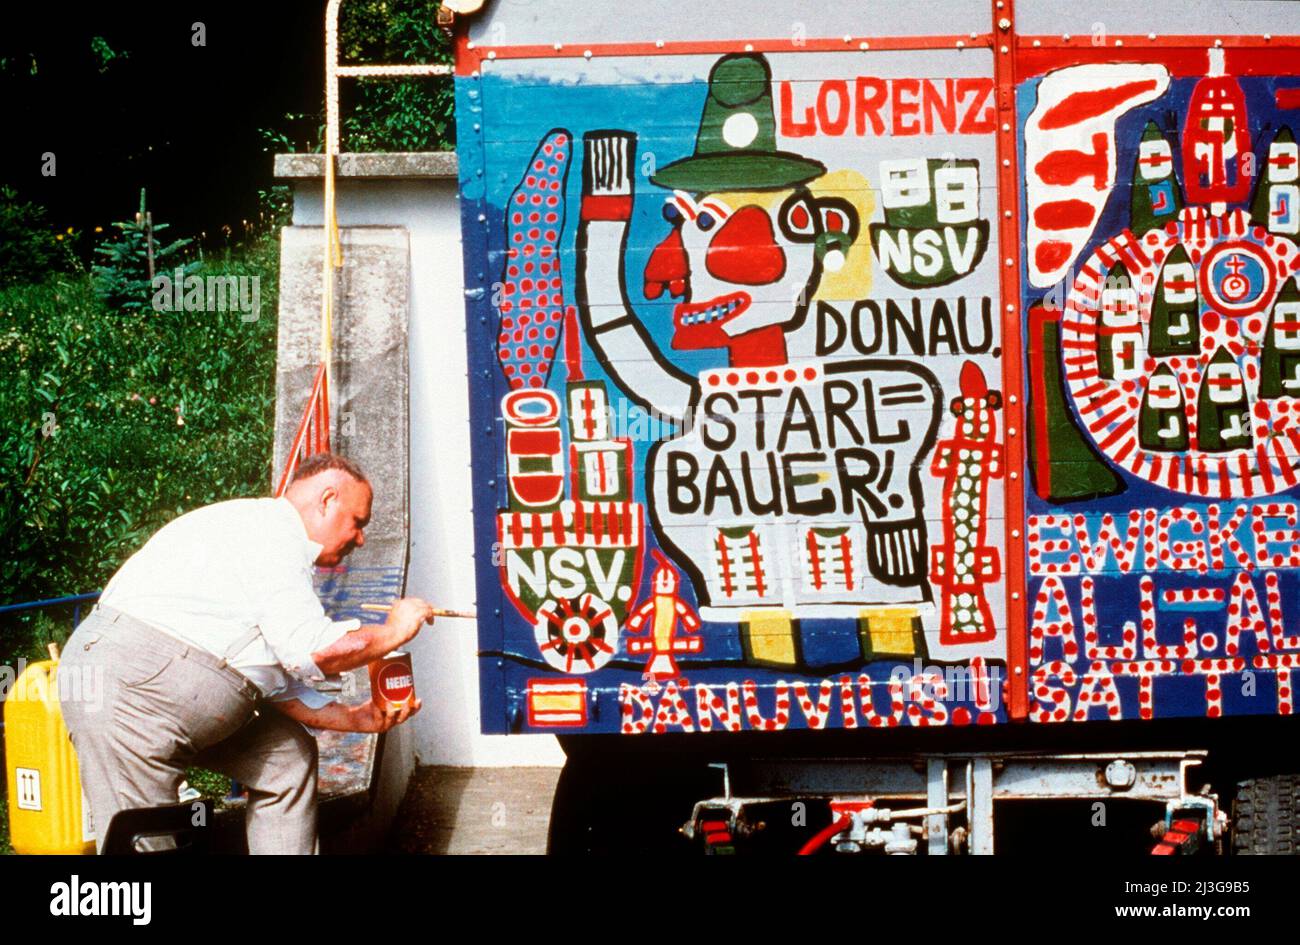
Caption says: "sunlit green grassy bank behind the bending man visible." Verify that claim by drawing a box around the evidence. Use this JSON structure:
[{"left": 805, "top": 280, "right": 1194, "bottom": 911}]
[{"left": 0, "top": 233, "right": 280, "bottom": 662}]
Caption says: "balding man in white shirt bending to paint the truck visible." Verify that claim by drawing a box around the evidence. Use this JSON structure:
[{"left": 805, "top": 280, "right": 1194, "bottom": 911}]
[{"left": 61, "top": 454, "right": 433, "bottom": 854}]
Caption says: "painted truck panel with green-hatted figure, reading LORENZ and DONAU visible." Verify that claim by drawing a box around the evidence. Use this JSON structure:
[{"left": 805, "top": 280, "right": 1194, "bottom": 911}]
[{"left": 460, "top": 46, "right": 1006, "bottom": 733}]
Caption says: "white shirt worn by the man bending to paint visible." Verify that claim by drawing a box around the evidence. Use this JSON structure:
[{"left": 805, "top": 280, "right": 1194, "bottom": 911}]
[{"left": 100, "top": 498, "right": 361, "bottom": 708}]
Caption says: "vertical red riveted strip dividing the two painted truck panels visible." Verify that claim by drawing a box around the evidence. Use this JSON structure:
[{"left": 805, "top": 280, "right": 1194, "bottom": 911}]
[{"left": 991, "top": 0, "right": 1030, "bottom": 721}]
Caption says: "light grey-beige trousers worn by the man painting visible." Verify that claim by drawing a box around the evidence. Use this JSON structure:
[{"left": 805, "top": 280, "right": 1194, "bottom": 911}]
[{"left": 60, "top": 607, "right": 316, "bottom": 854}]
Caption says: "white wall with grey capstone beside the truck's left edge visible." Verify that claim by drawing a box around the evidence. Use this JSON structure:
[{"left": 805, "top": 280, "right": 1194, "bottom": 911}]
[{"left": 294, "top": 178, "right": 564, "bottom": 767}]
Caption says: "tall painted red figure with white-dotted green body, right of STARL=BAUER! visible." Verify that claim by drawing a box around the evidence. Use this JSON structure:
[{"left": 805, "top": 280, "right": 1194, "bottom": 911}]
[{"left": 930, "top": 361, "right": 1002, "bottom": 645}]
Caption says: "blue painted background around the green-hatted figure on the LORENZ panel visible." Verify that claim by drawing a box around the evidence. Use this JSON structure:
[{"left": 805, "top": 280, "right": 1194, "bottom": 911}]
[{"left": 456, "top": 74, "right": 1004, "bottom": 733}]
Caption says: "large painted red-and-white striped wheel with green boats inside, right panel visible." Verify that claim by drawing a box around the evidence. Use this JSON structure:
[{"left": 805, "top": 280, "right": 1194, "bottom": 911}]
[{"left": 1061, "top": 220, "right": 1300, "bottom": 499}]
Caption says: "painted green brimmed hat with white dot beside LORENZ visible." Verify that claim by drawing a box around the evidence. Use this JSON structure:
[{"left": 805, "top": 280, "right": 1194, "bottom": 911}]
[{"left": 650, "top": 53, "right": 826, "bottom": 192}]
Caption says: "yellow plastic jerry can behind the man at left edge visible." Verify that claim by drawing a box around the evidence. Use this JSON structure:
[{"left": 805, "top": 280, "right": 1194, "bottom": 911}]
[{"left": 4, "top": 643, "right": 95, "bottom": 854}]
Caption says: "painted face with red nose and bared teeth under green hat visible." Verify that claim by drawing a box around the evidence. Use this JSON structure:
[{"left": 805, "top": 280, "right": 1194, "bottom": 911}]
[{"left": 645, "top": 187, "right": 857, "bottom": 363}]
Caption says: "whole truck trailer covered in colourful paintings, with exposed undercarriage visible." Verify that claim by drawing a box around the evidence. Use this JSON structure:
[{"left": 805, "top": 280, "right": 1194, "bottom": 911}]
[{"left": 455, "top": 0, "right": 1300, "bottom": 854}]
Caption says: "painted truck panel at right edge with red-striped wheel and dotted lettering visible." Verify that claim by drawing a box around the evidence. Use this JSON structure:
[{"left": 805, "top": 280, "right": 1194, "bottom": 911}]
[{"left": 1018, "top": 49, "right": 1300, "bottom": 721}]
